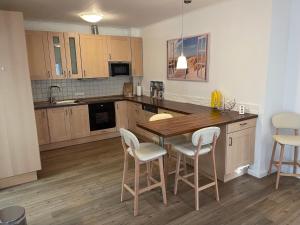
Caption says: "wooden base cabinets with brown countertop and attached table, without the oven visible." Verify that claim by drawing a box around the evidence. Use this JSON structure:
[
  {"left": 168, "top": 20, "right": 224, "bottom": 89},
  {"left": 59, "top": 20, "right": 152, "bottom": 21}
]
[{"left": 35, "top": 96, "right": 257, "bottom": 182}]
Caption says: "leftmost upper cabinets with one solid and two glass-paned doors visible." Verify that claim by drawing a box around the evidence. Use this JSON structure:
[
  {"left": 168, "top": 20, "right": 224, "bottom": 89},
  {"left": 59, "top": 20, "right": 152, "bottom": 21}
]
[{"left": 26, "top": 31, "right": 82, "bottom": 80}]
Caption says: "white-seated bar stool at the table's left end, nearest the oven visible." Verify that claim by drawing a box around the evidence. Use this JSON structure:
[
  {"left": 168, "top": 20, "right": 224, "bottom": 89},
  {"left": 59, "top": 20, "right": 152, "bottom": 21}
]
[{"left": 120, "top": 128, "right": 167, "bottom": 216}]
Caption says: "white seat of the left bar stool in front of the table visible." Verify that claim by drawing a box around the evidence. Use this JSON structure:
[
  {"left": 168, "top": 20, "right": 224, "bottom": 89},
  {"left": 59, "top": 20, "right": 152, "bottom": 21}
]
[{"left": 127, "top": 143, "right": 167, "bottom": 162}]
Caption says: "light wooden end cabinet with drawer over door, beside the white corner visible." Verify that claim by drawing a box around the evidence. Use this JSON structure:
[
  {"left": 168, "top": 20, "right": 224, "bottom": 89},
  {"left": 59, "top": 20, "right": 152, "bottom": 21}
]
[{"left": 199, "top": 119, "right": 256, "bottom": 182}]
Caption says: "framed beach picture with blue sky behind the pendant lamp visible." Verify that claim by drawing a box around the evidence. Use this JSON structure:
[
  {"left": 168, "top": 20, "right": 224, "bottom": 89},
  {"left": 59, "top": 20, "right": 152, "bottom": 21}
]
[{"left": 167, "top": 34, "right": 209, "bottom": 81}]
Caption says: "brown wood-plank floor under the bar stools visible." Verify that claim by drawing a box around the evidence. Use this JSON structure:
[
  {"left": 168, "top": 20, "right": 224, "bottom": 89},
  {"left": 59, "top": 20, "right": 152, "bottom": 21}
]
[{"left": 0, "top": 138, "right": 300, "bottom": 225}]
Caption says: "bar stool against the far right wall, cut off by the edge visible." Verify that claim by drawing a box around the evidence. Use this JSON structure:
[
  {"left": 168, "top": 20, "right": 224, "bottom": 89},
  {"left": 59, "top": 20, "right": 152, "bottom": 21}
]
[{"left": 269, "top": 112, "right": 300, "bottom": 189}]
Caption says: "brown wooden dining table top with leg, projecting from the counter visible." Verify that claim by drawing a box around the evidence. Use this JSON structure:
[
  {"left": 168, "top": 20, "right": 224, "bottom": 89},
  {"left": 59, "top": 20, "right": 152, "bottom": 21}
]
[{"left": 137, "top": 107, "right": 257, "bottom": 181}]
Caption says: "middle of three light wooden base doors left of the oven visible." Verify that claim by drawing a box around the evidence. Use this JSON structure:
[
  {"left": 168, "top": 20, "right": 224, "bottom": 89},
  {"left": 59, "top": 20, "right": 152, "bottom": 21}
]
[{"left": 47, "top": 107, "right": 71, "bottom": 143}]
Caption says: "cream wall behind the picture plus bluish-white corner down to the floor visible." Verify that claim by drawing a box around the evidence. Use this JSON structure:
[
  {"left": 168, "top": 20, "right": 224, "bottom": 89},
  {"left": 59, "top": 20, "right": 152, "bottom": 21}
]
[{"left": 142, "top": 0, "right": 298, "bottom": 177}]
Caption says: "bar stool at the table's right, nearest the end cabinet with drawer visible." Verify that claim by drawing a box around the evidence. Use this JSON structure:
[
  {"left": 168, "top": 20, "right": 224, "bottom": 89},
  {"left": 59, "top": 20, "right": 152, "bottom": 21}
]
[{"left": 173, "top": 127, "right": 220, "bottom": 210}]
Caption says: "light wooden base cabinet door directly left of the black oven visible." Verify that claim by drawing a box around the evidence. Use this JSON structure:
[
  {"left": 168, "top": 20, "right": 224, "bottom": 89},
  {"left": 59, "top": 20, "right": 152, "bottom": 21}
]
[{"left": 69, "top": 105, "right": 90, "bottom": 139}]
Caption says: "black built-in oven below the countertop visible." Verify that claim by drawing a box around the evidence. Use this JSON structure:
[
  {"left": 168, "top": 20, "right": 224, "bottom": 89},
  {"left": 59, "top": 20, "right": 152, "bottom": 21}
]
[{"left": 89, "top": 102, "right": 116, "bottom": 131}]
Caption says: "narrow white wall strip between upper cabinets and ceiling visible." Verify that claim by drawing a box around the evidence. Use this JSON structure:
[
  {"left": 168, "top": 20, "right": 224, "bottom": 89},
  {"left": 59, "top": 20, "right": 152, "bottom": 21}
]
[{"left": 25, "top": 21, "right": 140, "bottom": 37}]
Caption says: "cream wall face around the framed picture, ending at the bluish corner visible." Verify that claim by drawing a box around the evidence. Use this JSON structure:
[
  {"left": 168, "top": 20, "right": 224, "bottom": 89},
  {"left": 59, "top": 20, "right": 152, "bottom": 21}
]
[{"left": 142, "top": 0, "right": 272, "bottom": 112}]
